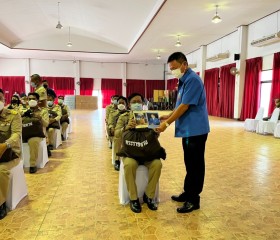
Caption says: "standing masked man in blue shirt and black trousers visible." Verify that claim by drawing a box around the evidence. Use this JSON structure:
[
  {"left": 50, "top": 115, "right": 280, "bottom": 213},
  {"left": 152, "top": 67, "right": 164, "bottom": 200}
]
[{"left": 156, "top": 52, "right": 210, "bottom": 213}]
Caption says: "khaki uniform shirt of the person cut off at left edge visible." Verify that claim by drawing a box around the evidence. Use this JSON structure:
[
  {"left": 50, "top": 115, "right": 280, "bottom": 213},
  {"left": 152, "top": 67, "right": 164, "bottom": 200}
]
[{"left": 0, "top": 108, "right": 22, "bottom": 155}]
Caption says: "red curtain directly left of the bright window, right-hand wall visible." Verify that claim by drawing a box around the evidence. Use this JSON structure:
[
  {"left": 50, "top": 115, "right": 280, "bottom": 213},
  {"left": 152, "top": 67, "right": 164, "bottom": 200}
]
[{"left": 240, "top": 57, "right": 262, "bottom": 120}]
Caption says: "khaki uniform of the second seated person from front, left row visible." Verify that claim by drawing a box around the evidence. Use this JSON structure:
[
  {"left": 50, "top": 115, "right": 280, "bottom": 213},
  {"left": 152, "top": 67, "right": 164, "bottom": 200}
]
[{"left": 23, "top": 108, "right": 49, "bottom": 167}]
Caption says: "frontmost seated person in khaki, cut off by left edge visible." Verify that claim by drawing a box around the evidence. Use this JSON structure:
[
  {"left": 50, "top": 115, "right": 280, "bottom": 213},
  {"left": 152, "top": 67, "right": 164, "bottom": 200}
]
[{"left": 0, "top": 89, "right": 21, "bottom": 220}]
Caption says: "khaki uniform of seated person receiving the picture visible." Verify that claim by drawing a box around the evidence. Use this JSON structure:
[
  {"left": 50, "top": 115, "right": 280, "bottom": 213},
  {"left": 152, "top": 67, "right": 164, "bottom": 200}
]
[{"left": 115, "top": 111, "right": 162, "bottom": 200}]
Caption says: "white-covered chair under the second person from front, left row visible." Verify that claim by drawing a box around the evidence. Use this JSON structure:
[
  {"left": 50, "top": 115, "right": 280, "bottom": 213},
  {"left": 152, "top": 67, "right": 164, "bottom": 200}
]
[{"left": 22, "top": 138, "right": 49, "bottom": 168}]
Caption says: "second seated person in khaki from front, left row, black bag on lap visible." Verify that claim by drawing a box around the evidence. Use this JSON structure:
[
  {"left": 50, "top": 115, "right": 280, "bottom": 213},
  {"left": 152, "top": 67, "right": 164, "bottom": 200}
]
[{"left": 22, "top": 92, "right": 49, "bottom": 173}]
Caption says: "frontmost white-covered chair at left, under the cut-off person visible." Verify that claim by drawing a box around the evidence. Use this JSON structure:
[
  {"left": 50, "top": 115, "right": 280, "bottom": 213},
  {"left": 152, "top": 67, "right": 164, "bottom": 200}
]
[{"left": 6, "top": 161, "right": 27, "bottom": 210}]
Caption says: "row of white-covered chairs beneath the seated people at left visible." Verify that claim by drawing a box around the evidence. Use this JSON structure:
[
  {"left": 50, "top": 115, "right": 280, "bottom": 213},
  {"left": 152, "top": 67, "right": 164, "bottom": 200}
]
[{"left": 6, "top": 122, "right": 72, "bottom": 210}]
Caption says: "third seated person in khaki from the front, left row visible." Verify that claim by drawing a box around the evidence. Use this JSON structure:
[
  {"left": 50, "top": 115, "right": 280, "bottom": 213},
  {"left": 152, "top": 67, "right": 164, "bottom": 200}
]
[{"left": 47, "top": 95, "right": 61, "bottom": 150}]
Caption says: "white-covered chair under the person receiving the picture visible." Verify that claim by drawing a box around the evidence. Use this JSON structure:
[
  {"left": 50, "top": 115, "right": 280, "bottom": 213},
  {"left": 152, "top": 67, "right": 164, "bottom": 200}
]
[{"left": 119, "top": 161, "right": 159, "bottom": 205}]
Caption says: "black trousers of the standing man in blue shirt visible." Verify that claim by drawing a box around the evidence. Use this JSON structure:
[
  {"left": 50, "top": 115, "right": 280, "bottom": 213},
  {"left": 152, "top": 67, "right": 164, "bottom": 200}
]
[{"left": 182, "top": 134, "right": 208, "bottom": 203}]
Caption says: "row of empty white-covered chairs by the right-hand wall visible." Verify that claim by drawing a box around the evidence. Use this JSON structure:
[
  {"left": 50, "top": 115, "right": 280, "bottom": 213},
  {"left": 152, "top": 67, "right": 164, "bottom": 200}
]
[{"left": 244, "top": 107, "right": 280, "bottom": 138}]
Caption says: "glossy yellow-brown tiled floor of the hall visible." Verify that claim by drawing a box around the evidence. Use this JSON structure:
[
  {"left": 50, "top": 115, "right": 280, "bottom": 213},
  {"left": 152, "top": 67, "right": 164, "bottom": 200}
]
[{"left": 0, "top": 110, "right": 280, "bottom": 240}]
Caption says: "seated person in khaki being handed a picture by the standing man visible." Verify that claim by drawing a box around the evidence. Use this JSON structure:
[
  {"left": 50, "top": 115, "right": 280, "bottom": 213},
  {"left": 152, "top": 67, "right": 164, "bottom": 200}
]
[{"left": 115, "top": 93, "right": 162, "bottom": 213}]
